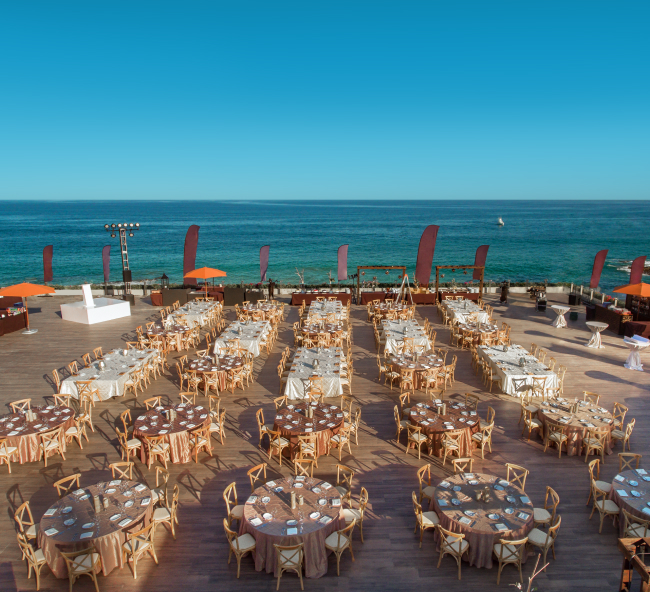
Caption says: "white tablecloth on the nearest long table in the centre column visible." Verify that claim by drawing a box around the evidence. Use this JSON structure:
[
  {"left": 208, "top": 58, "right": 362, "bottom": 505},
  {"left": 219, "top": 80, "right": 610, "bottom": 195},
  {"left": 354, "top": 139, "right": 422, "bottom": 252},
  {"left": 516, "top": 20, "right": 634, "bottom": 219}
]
[{"left": 285, "top": 347, "right": 343, "bottom": 400}]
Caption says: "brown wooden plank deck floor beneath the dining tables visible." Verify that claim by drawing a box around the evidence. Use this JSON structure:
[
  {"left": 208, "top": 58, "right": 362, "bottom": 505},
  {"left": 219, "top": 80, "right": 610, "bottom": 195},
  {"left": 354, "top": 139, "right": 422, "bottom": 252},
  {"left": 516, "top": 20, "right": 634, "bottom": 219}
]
[{"left": 0, "top": 297, "right": 650, "bottom": 592}]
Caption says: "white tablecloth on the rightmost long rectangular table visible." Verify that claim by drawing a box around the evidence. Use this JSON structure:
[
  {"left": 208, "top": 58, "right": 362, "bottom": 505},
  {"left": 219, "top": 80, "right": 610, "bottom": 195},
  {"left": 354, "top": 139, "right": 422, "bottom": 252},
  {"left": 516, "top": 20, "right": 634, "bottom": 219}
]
[{"left": 478, "top": 345, "right": 558, "bottom": 397}]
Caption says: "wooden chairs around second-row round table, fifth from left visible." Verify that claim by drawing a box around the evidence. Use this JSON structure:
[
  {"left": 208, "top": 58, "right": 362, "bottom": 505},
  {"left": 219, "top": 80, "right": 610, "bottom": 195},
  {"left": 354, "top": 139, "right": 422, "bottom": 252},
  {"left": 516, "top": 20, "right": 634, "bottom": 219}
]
[{"left": 519, "top": 385, "right": 636, "bottom": 463}]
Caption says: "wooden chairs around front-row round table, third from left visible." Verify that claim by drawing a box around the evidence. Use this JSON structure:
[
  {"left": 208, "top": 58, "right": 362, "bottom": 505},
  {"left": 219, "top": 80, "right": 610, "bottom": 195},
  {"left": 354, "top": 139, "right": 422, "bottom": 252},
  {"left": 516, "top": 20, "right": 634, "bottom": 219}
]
[{"left": 411, "top": 458, "right": 562, "bottom": 584}]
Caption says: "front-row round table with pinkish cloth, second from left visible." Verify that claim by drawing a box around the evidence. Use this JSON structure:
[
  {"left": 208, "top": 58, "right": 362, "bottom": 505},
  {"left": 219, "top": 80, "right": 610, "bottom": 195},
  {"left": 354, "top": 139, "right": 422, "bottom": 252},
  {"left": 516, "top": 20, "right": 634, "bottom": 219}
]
[{"left": 239, "top": 476, "right": 345, "bottom": 578}]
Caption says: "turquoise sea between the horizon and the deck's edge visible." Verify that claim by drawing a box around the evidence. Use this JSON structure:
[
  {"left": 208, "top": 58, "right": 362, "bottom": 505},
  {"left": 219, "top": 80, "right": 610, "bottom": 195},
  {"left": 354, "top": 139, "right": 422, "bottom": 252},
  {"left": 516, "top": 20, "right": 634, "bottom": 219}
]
[{"left": 0, "top": 200, "right": 650, "bottom": 290}]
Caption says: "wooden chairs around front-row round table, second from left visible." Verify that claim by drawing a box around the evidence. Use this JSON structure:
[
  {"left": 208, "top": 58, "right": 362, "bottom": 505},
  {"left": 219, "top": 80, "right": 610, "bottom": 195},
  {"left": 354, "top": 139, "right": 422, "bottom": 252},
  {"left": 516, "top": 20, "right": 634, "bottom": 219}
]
[{"left": 223, "top": 459, "right": 369, "bottom": 590}]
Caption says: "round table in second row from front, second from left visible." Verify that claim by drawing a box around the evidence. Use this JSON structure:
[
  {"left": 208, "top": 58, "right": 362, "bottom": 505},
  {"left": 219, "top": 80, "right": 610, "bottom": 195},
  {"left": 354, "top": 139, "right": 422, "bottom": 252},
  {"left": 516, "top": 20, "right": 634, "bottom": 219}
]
[{"left": 133, "top": 403, "right": 210, "bottom": 464}]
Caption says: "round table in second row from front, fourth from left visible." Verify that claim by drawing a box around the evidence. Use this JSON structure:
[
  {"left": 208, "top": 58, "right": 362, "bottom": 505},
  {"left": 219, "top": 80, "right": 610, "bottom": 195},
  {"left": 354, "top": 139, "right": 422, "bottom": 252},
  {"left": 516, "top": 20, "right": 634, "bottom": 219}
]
[{"left": 409, "top": 401, "right": 480, "bottom": 458}]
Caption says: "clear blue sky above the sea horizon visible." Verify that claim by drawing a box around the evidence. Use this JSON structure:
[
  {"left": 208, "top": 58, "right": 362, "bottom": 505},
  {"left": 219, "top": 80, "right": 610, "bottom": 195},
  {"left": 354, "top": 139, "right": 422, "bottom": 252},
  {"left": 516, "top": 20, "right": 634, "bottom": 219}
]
[{"left": 0, "top": 0, "right": 650, "bottom": 200}]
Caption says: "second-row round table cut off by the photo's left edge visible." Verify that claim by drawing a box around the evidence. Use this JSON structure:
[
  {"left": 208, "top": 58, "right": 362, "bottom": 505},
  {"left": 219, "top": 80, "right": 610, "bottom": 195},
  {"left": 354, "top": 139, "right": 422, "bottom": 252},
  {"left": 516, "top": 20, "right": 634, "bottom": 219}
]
[{"left": 0, "top": 405, "right": 75, "bottom": 464}]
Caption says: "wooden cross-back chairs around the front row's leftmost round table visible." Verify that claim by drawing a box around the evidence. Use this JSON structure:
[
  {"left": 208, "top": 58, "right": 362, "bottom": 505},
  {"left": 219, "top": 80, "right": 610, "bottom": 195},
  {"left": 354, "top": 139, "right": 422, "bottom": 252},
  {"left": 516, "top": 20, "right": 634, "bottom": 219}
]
[{"left": 14, "top": 462, "right": 180, "bottom": 591}]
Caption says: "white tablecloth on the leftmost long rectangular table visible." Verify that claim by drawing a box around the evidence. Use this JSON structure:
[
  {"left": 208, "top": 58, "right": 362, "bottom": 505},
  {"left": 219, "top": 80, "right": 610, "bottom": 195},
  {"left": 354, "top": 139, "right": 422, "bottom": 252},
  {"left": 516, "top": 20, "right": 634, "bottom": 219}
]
[{"left": 61, "top": 349, "right": 158, "bottom": 401}]
